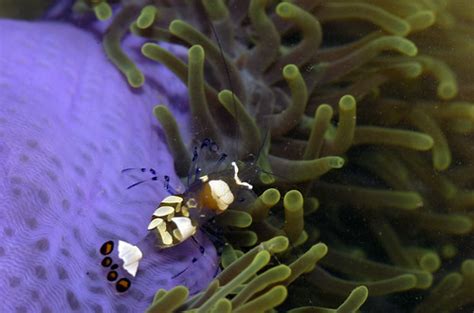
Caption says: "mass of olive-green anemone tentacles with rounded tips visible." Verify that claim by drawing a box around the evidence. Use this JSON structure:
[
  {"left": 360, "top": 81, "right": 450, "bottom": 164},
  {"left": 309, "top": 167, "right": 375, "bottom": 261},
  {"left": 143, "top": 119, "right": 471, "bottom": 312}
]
[{"left": 72, "top": 0, "right": 474, "bottom": 312}]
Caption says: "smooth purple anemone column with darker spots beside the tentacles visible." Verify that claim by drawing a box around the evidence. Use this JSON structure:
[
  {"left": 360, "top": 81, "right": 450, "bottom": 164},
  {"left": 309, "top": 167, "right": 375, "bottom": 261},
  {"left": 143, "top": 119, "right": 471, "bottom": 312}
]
[{"left": 0, "top": 20, "right": 217, "bottom": 312}]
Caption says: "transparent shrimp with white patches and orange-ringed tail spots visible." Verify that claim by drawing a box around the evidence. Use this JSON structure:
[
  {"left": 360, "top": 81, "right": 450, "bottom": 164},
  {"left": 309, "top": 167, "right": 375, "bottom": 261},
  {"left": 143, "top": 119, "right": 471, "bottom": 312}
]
[{"left": 100, "top": 162, "right": 252, "bottom": 292}]
